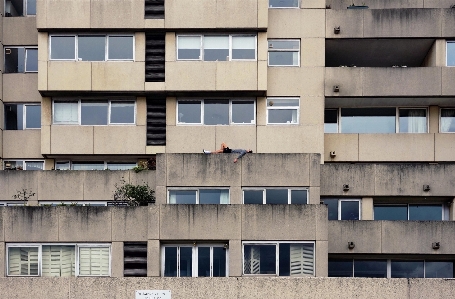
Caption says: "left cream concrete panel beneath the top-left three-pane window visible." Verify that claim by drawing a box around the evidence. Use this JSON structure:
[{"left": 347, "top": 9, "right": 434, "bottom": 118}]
[{"left": 47, "top": 62, "right": 91, "bottom": 90}]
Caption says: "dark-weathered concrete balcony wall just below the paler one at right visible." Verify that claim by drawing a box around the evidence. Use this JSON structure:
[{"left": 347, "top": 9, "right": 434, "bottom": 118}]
[{"left": 321, "top": 163, "right": 455, "bottom": 197}]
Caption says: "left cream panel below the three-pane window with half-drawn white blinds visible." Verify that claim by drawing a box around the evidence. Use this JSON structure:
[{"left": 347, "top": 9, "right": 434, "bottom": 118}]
[{"left": 165, "top": 62, "right": 218, "bottom": 91}]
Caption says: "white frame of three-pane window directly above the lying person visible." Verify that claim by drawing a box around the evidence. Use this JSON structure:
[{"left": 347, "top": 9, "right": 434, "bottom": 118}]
[{"left": 175, "top": 98, "right": 257, "bottom": 126}]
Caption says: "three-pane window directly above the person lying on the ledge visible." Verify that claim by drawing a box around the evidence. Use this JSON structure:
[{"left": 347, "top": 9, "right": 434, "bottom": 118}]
[{"left": 177, "top": 99, "right": 256, "bottom": 125}]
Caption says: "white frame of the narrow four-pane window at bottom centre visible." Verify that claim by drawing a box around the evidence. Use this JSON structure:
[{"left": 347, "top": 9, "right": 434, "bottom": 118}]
[{"left": 161, "top": 242, "right": 229, "bottom": 277}]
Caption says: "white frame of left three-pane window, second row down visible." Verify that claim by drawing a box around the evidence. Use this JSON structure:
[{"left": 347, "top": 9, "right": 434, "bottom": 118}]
[{"left": 52, "top": 98, "right": 137, "bottom": 127}]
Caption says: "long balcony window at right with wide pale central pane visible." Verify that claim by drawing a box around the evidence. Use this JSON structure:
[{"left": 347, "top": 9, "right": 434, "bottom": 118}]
[{"left": 324, "top": 108, "right": 428, "bottom": 133}]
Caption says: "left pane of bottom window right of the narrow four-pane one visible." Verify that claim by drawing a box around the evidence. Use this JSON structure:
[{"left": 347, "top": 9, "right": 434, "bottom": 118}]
[{"left": 243, "top": 245, "right": 276, "bottom": 274}]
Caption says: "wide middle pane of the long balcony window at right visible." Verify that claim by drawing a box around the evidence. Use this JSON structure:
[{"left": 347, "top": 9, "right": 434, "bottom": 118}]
[{"left": 340, "top": 108, "right": 396, "bottom": 133}]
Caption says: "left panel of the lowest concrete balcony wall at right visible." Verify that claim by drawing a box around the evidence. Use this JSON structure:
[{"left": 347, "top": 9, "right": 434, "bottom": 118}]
[{"left": 328, "top": 220, "right": 382, "bottom": 254}]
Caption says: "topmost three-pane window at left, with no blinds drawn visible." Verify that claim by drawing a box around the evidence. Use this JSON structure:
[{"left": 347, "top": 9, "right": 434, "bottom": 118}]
[{"left": 49, "top": 34, "right": 134, "bottom": 61}]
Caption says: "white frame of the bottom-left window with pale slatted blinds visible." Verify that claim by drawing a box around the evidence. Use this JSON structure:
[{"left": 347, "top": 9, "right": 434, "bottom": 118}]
[{"left": 5, "top": 243, "right": 112, "bottom": 277}]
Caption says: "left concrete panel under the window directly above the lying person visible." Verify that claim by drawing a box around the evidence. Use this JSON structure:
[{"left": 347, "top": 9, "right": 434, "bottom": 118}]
[{"left": 166, "top": 126, "right": 216, "bottom": 153}]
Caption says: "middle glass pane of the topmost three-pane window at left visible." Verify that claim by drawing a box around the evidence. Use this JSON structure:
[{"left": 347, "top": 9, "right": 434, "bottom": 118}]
[{"left": 77, "top": 35, "right": 106, "bottom": 61}]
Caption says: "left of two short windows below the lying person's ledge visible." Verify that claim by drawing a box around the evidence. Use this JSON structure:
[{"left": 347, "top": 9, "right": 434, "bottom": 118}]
[{"left": 168, "top": 189, "right": 229, "bottom": 204}]
